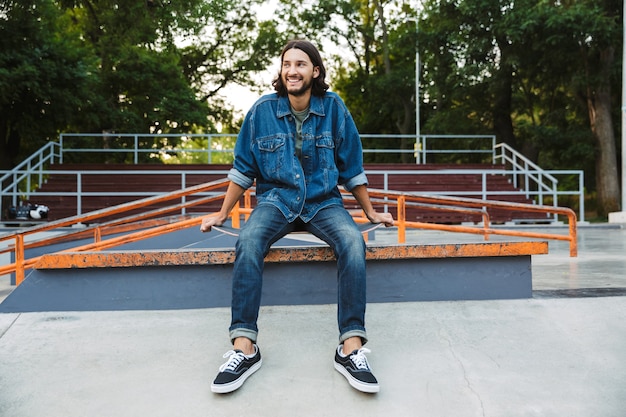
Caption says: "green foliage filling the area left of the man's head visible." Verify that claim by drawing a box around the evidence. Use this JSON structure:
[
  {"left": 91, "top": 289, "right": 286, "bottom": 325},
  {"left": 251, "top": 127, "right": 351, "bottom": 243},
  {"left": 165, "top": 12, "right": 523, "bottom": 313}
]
[{"left": 0, "top": 0, "right": 282, "bottom": 168}]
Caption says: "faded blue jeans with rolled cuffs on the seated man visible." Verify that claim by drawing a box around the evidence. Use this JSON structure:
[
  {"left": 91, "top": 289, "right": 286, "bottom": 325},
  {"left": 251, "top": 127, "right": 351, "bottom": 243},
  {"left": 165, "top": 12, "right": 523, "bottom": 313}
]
[{"left": 229, "top": 204, "right": 367, "bottom": 343}]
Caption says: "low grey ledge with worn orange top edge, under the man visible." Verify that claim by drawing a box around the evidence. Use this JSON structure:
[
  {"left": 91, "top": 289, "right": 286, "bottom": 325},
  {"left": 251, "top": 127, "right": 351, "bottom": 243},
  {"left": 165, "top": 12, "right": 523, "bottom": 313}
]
[{"left": 0, "top": 242, "right": 548, "bottom": 313}]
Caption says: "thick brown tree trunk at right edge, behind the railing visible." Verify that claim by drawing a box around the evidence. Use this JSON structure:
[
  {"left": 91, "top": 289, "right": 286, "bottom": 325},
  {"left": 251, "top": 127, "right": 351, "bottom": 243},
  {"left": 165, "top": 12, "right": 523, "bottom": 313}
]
[{"left": 587, "top": 47, "right": 620, "bottom": 217}]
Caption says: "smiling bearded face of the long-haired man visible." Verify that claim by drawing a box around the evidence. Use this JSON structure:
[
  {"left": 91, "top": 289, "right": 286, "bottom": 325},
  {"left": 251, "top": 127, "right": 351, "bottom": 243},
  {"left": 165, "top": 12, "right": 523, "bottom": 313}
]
[{"left": 280, "top": 48, "right": 320, "bottom": 97}]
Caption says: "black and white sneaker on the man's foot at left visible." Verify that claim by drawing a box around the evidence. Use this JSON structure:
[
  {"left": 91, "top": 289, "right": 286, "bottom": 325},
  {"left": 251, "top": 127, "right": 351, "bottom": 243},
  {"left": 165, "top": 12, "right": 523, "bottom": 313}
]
[{"left": 211, "top": 345, "right": 262, "bottom": 394}]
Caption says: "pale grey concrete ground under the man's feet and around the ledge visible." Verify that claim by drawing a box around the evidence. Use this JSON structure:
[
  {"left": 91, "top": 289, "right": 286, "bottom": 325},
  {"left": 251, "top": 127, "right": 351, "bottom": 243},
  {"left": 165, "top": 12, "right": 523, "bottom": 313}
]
[{"left": 0, "top": 225, "right": 626, "bottom": 417}]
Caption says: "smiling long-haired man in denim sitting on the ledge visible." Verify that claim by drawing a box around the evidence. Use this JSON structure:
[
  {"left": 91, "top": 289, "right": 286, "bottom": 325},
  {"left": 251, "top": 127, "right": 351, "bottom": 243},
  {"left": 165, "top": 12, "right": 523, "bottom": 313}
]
[{"left": 201, "top": 40, "right": 393, "bottom": 393}]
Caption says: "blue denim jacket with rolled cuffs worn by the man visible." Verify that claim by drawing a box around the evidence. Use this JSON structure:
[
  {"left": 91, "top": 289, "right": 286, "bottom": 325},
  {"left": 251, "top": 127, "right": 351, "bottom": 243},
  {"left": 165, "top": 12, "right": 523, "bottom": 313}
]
[{"left": 228, "top": 92, "right": 367, "bottom": 222}]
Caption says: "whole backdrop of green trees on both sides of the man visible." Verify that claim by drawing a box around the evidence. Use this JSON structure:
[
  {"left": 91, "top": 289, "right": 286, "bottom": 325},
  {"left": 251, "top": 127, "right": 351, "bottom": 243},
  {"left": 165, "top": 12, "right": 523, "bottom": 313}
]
[{"left": 0, "top": 0, "right": 623, "bottom": 211}]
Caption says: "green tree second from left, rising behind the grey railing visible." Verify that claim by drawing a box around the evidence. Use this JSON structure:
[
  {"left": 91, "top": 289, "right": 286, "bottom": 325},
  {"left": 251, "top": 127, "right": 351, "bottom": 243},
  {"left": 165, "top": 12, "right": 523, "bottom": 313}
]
[{"left": 61, "top": 0, "right": 211, "bottom": 133}]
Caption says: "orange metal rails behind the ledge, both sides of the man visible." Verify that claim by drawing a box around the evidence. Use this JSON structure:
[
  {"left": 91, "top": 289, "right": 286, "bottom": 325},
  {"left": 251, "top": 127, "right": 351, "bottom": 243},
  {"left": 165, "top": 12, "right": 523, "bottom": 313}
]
[{"left": 0, "top": 179, "right": 577, "bottom": 285}]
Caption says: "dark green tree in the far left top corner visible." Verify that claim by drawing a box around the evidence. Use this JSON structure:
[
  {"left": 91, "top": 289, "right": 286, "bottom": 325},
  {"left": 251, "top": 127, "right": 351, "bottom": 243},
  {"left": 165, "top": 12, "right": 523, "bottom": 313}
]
[{"left": 0, "top": 0, "right": 95, "bottom": 169}]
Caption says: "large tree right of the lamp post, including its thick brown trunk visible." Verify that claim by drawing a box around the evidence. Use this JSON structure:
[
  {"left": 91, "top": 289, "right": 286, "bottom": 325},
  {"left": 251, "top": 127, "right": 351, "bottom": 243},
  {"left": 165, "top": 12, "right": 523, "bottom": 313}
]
[{"left": 420, "top": 0, "right": 621, "bottom": 215}]
